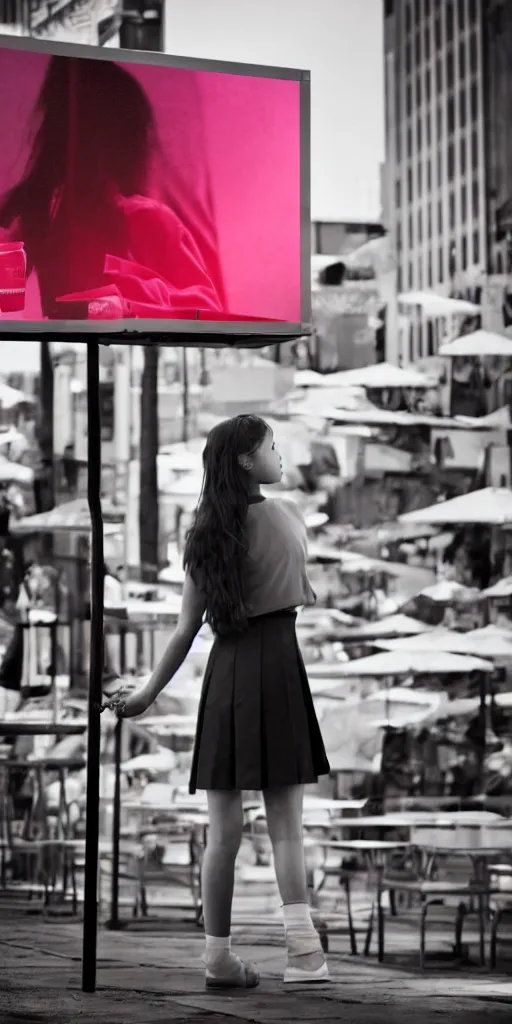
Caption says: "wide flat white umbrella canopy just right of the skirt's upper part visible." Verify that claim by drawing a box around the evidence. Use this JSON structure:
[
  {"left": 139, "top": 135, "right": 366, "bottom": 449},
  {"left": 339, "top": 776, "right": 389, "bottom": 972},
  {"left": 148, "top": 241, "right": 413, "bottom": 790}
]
[{"left": 307, "top": 650, "right": 494, "bottom": 679}]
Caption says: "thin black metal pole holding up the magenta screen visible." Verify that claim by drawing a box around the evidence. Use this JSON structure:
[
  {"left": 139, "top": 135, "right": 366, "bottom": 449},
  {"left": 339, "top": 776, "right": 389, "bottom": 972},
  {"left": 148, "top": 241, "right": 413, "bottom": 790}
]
[{"left": 82, "top": 339, "right": 104, "bottom": 992}]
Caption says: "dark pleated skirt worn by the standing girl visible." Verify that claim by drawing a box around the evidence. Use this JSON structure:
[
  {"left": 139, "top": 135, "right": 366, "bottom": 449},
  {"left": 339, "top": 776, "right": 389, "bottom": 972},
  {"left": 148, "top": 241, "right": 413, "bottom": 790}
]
[{"left": 189, "top": 611, "right": 330, "bottom": 793}]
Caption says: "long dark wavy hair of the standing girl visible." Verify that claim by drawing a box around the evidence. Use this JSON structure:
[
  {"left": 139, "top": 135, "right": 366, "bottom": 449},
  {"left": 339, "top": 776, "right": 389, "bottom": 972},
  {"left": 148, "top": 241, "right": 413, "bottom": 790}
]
[{"left": 183, "top": 416, "right": 269, "bottom": 635}]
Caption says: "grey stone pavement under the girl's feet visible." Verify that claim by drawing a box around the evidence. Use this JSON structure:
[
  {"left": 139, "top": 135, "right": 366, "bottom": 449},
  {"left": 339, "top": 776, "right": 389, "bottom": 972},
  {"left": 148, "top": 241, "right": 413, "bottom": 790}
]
[{"left": 0, "top": 901, "right": 512, "bottom": 1024}]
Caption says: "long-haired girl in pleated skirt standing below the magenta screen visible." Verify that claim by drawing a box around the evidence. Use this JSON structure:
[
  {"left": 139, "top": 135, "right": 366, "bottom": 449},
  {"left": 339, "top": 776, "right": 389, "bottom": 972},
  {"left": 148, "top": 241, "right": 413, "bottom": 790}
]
[{"left": 112, "top": 416, "right": 330, "bottom": 988}]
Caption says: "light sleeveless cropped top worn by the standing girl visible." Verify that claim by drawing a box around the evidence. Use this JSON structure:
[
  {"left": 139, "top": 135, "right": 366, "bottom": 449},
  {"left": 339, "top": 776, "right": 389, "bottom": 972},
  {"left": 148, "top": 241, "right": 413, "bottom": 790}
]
[{"left": 244, "top": 498, "right": 316, "bottom": 617}]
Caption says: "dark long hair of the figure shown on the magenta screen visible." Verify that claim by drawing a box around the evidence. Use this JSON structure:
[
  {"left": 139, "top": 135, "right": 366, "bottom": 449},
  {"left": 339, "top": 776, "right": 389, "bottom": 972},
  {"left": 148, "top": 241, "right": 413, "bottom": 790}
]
[{"left": 0, "top": 56, "right": 159, "bottom": 269}]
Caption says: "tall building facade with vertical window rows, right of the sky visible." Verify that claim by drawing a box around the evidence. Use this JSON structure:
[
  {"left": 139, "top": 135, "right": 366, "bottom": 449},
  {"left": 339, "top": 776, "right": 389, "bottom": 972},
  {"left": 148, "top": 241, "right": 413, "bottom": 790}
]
[{"left": 384, "top": 0, "right": 489, "bottom": 362}]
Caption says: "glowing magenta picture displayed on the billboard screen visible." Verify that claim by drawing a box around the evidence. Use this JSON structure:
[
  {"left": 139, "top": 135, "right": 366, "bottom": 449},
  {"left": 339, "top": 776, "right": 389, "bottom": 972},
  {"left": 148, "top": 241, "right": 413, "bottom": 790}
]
[{"left": 0, "top": 44, "right": 301, "bottom": 329}]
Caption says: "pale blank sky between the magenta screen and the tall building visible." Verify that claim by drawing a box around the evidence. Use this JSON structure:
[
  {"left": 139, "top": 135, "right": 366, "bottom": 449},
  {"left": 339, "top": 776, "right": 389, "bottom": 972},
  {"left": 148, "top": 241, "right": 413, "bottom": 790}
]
[{"left": 0, "top": 0, "right": 384, "bottom": 373}]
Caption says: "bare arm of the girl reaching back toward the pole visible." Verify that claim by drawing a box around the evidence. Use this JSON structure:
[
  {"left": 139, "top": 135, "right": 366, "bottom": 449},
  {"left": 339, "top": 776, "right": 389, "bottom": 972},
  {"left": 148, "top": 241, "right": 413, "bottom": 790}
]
[{"left": 118, "top": 573, "right": 206, "bottom": 718}]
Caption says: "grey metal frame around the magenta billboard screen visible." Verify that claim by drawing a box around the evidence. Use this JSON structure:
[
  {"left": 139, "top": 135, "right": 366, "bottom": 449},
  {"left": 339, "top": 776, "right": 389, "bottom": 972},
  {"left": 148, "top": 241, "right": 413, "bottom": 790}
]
[{"left": 0, "top": 34, "right": 312, "bottom": 347}]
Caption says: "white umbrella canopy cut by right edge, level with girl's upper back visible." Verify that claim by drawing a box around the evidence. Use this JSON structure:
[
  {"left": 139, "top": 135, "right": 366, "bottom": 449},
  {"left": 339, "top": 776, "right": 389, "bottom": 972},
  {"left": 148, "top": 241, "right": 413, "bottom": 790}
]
[{"left": 399, "top": 487, "right": 512, "bottom": 525}]
